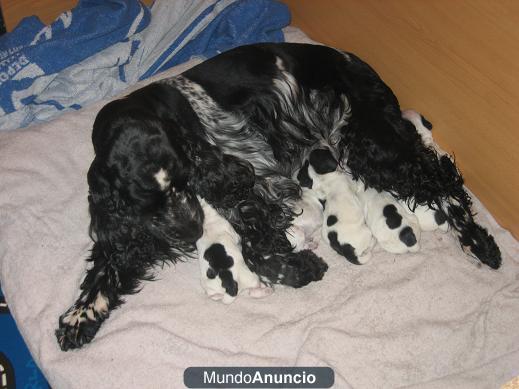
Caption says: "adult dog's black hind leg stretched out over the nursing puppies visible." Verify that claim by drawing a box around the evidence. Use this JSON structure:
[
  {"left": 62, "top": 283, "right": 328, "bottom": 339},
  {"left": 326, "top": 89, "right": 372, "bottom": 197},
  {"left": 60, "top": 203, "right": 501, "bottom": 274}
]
[{"left": 338, "top": 54, "right": 501, "bottom": 268}]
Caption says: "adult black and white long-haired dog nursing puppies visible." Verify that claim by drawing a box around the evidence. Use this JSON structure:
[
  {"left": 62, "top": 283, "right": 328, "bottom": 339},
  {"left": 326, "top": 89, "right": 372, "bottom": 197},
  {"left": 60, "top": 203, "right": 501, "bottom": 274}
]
[{"left": 56, "top": 43, "right": 501, "bottom": 350}]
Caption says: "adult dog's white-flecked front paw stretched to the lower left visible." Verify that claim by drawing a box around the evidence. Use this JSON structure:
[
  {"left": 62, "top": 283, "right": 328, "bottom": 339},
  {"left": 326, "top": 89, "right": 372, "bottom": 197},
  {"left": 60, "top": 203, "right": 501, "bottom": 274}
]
[{"left": 56, "top": 306, "right": 103, "bottom": 351}]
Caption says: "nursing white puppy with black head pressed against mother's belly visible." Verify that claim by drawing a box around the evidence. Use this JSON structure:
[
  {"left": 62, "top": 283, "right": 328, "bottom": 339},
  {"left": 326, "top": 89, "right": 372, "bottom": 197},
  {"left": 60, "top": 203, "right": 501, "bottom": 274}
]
[{"left": 298, "top": 149, "right": 375, "bottom": 265}]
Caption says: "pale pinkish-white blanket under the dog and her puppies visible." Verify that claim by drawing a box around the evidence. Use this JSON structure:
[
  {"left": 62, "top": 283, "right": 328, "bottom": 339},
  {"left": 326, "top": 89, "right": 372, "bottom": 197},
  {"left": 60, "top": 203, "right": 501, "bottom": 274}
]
[{"left": 0, "top": 30, "right": 519, "bottom": 389}]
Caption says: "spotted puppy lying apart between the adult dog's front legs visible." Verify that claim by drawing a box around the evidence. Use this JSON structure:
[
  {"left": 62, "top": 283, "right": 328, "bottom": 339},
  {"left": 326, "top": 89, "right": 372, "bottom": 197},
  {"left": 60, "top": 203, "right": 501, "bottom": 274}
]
[{"left": 196, "top": 198, "right": 273, "bottom": 304}]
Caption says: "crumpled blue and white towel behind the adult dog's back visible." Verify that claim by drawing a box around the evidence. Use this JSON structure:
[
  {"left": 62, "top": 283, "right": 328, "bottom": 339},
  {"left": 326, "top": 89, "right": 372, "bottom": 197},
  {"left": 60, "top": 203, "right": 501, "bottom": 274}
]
[{"left": 0, "top": 0, "right": 290, "bottom": 130}]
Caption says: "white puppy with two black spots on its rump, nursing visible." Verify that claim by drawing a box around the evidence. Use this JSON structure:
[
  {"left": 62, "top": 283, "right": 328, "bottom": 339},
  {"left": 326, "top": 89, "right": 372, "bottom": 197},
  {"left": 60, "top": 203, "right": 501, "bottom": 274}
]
[{"left": 352, "top": 181, "right": 420, "bottom": 254}]
